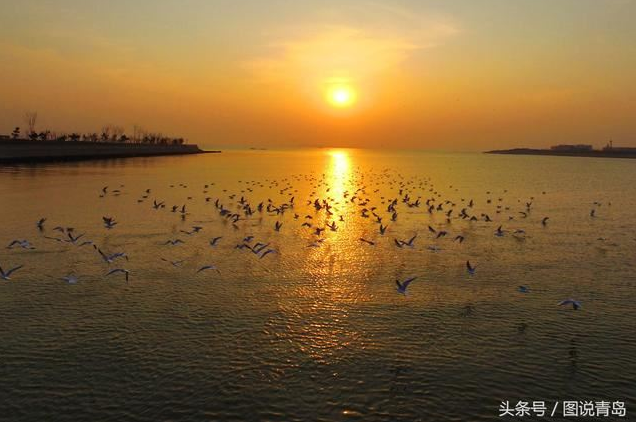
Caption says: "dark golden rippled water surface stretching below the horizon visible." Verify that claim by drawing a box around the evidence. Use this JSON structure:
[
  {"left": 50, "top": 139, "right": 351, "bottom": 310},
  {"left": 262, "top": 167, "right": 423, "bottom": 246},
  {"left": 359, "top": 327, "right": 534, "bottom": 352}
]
[{"left": 0, "top": 150, "right": 636, "bottom": 421}]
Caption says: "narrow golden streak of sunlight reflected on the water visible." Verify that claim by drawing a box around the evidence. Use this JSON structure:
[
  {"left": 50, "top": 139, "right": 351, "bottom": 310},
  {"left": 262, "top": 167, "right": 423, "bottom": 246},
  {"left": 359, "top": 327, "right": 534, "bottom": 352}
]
[{"left": 284, "top": 150, "right": 363, "bottom": 362}]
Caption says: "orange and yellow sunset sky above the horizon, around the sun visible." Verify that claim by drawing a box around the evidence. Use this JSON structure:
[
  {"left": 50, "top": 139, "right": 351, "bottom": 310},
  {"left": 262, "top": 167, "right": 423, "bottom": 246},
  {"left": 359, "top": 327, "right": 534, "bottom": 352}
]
[{"left": 0, "top": 0, "right": 636, "bottom": 150}]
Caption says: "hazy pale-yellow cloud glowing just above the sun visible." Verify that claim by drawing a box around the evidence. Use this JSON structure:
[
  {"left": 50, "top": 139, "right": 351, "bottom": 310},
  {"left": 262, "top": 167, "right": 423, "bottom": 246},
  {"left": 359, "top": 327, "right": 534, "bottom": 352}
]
[{"left": 245, "top": 3, "right": 460, "bottom": 86}]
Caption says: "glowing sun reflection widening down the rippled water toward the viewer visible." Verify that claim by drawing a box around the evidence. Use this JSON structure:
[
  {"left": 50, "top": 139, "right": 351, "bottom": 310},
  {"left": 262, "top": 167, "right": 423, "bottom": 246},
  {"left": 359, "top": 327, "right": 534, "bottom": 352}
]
[{"left": 272, "top": 150, "right": 380, "bottom": 362}]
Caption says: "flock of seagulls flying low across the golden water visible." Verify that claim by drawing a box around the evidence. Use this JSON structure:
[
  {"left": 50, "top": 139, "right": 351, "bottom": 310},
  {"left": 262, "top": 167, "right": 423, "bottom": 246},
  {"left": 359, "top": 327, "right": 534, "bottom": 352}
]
[{"left": 0, "top": 169, "right": 611, "bottom": 310}]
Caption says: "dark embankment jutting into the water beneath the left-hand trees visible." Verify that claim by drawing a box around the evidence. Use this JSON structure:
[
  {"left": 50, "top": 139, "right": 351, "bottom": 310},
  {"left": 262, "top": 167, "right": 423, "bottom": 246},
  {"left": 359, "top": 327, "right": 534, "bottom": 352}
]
[{"left": 0, "top": 140, "right": 221, "bottom": 165}]
